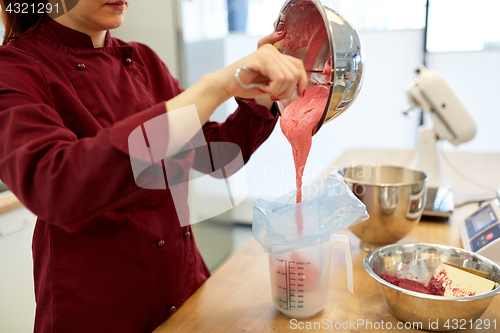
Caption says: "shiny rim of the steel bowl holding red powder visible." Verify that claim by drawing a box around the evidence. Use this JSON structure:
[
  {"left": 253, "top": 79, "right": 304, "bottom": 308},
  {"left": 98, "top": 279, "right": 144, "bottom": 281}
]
[{"left": 363, "top": 243, "right": 500, "bottom": 302}]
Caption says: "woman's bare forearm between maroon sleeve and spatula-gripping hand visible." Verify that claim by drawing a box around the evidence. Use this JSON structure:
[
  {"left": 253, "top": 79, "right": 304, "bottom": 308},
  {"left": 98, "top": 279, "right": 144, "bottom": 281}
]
[{"left": 166, "top": 73, "right": 231, "bottom": 126}]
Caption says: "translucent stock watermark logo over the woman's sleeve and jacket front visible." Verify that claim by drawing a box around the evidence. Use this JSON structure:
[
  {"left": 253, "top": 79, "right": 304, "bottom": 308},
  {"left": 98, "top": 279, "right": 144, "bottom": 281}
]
[{"left": 128, "top": 105, "right": 248, "bottom": 226}]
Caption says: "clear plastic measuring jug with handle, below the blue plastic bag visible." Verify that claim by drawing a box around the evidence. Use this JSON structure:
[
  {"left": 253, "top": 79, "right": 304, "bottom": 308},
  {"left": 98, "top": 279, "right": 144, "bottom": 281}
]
[{"left": 269, "top": 235, "right": 353, "bottom": 319}]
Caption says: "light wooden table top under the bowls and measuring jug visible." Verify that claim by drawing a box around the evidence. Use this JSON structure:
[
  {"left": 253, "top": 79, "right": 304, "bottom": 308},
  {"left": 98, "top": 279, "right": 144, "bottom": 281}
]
[{"left": 154, "top": 149, "right": 500, "bottom": 333}]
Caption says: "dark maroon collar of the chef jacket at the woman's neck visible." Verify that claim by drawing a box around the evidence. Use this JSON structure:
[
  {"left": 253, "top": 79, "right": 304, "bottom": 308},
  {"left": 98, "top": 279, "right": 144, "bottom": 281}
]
[{"left": 40, "top": 16, "right": 111, "bottom": 49}]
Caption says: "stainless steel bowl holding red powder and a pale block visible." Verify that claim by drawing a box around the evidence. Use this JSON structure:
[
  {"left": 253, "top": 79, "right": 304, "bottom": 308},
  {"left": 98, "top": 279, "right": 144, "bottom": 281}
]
[{"left": 363, "top": 243, "right": 500, "bottom": 331}]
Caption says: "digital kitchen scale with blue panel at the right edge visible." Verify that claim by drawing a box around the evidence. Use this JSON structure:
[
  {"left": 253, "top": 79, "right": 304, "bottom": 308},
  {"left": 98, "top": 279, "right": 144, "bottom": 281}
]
[{"left": 460, "top": 199, "right": 500, "bottom": 264}]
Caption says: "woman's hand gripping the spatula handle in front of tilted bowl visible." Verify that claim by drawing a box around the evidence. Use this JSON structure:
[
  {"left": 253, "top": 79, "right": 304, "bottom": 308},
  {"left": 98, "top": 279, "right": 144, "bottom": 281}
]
[{"left": 208, "top": 30, "right": 308, "bottom": 100}]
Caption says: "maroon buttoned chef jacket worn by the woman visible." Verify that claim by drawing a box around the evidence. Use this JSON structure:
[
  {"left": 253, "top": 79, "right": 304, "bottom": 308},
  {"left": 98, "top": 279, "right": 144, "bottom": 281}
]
[{"left": 0, "top": 18, "right": 277, "bottom": 333}]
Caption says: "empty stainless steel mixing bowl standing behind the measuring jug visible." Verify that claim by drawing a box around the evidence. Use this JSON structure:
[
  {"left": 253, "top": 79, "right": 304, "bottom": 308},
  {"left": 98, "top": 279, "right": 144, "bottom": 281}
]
[{"left": 338, "top": 164, "right": 427, "bottom": 251}]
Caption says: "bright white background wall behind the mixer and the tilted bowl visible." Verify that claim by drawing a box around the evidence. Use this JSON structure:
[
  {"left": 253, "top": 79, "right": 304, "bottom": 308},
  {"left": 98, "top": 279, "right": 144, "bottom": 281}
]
[{"left": 221, "top": 30, "right": 500, "bottom": 222}]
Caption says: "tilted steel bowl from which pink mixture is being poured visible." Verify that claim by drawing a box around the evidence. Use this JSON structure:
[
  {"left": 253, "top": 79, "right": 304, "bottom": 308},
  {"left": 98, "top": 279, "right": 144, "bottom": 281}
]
[{"left": 276, "top": 0, "right": 364, "bottom": 134}]
